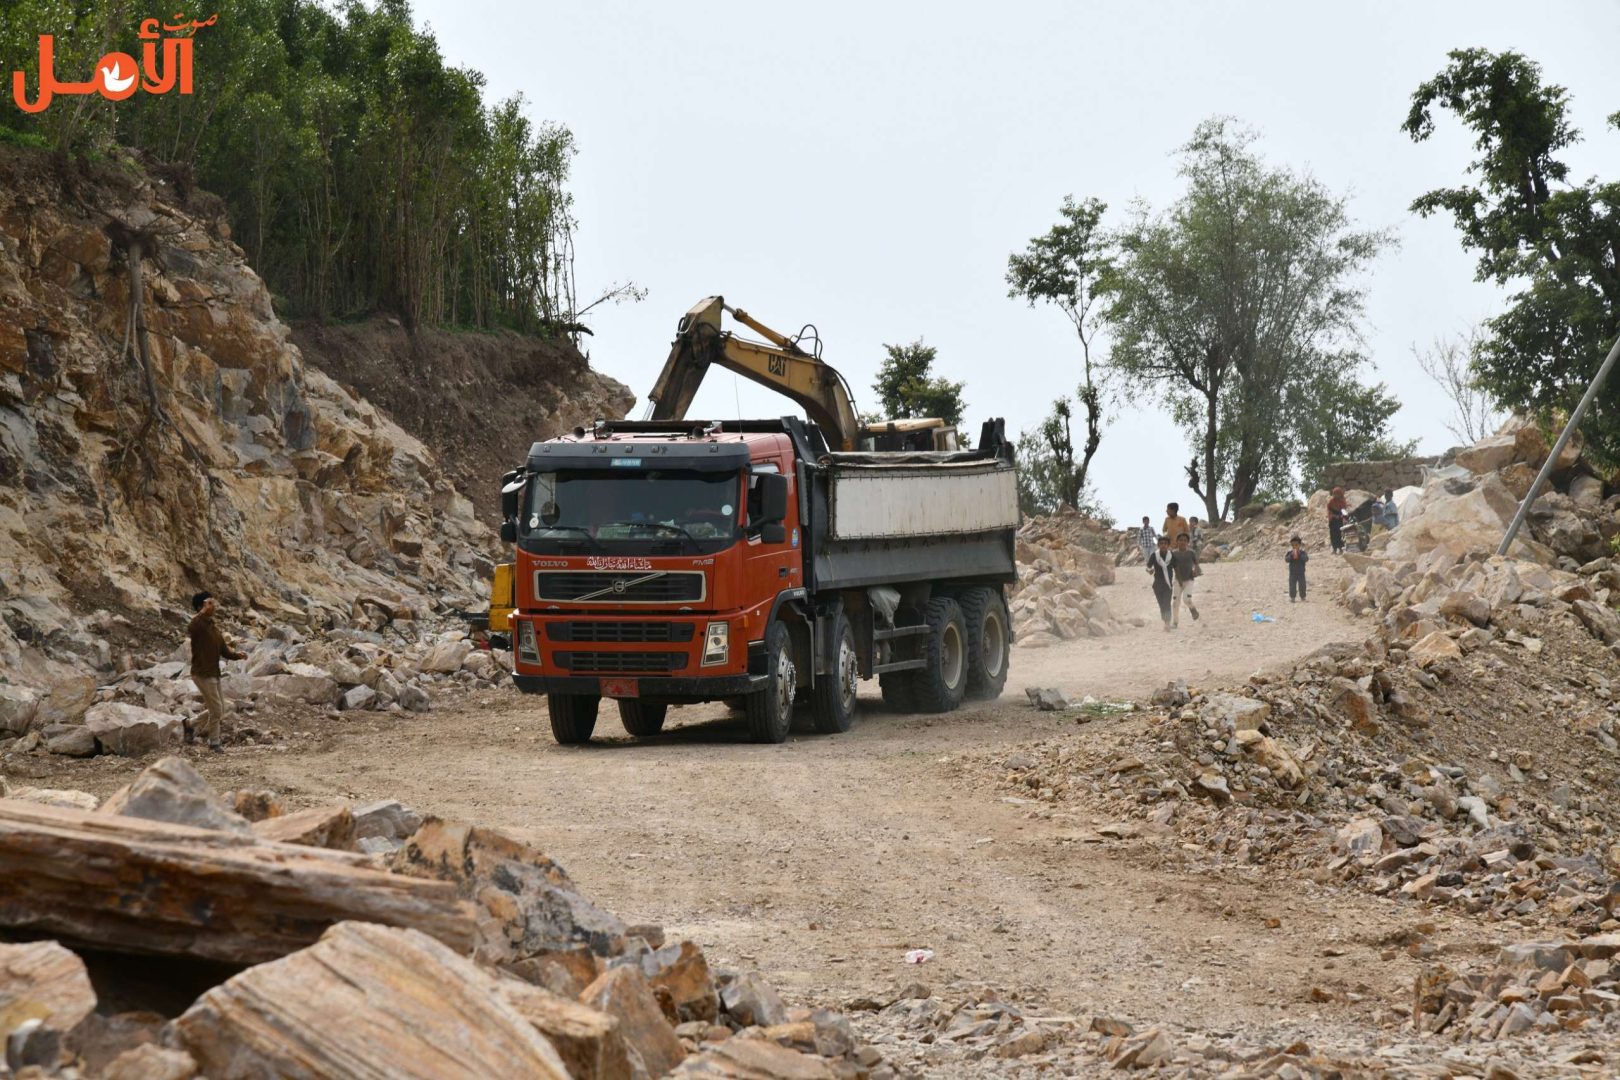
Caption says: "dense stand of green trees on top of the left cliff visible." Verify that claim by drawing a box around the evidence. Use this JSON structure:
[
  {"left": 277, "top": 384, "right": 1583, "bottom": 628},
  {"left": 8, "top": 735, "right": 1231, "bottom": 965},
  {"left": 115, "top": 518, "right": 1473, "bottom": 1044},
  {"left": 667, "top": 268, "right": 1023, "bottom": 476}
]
[{"left": 0, "top": 0, "right": 612, "bottom": 334}]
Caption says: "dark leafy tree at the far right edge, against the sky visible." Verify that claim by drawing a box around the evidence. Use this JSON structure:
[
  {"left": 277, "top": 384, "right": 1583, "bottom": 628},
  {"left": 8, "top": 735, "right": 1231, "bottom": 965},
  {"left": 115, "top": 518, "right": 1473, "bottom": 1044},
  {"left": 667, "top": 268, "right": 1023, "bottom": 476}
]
[{"left": 1401, "top": 49, "right": 1620, "bottom": 461}]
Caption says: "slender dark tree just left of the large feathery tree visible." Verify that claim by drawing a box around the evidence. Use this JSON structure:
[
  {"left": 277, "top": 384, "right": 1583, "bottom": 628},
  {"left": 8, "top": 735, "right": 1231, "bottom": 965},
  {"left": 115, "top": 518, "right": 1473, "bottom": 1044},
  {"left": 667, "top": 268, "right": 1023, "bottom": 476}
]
[{"left": 1006, "top": 196, "right": 1111, "bottom": 505}]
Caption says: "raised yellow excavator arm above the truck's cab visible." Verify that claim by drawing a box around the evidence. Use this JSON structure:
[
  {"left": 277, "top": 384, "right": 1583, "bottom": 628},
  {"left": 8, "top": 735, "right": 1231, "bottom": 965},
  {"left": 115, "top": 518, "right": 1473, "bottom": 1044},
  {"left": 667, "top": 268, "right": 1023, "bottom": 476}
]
[{"left": 648, "top": 296, "right": 862, "bottom": 450}]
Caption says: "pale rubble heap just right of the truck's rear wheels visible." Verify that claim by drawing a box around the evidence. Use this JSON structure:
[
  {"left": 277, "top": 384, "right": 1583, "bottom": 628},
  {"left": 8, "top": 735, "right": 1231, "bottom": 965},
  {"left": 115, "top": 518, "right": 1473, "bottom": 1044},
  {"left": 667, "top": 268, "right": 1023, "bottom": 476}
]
[{"left": 1008, "top": 510, "right": 1119, "bottom": 648}]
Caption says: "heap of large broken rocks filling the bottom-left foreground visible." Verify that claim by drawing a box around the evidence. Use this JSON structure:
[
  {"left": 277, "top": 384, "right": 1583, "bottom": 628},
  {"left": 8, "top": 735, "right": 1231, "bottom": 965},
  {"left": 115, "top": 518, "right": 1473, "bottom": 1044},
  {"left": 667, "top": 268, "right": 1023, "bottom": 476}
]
[{"left": 0, "top": 758, "right": 896, "bottom": 1080}]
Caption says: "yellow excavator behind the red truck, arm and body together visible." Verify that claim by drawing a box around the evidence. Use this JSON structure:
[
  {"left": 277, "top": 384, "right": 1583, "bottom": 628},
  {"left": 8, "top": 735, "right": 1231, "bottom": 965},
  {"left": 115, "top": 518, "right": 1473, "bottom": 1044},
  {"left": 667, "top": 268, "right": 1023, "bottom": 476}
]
[{"left": 480, "top": 296, "right": 957, "bottom": 641}]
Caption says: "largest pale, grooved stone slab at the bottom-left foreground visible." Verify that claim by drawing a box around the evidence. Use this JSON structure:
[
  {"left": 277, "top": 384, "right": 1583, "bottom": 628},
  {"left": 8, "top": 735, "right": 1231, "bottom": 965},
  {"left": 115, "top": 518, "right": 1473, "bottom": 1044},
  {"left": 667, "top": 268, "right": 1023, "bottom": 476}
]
[{"left": 173, "top": 923, "right": 569, "bottom": 1080}]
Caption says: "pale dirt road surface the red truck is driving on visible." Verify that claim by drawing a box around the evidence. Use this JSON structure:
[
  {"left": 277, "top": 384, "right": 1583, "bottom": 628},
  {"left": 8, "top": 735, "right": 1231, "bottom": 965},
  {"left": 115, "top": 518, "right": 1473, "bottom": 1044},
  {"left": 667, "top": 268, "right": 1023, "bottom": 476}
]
[{"left": 25, "top": 559, "right": 1490, "bottom": 1068}]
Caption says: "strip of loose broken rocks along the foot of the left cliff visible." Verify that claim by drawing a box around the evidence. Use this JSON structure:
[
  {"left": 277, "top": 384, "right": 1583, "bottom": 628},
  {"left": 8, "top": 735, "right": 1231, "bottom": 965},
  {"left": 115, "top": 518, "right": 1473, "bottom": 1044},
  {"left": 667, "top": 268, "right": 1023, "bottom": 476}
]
[{"left": 0, "top": 622, "right": 512, "bottom": 758}]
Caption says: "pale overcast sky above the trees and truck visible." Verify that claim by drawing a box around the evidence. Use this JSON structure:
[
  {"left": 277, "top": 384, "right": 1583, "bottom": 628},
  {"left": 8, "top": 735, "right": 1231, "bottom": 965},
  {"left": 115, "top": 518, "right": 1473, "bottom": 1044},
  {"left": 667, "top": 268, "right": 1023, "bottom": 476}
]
[{"left": 416, "top": 0, "right": 1620, "bottom": 520}]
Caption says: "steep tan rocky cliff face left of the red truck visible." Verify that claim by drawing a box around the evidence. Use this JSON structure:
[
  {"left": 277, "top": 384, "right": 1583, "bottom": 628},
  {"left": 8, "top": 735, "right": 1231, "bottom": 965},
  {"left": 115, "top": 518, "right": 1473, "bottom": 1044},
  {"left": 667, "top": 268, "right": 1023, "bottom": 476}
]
[{"left": 0, "top": 147, "right": 618, "bottom": 682}]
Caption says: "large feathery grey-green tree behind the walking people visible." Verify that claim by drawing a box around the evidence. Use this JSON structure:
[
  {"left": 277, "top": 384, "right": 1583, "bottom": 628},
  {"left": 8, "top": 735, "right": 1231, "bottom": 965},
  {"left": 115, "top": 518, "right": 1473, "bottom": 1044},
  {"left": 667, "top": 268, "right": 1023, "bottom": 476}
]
[{"left": 1103, "top": 118, "right": 1396, "bottom": 521}]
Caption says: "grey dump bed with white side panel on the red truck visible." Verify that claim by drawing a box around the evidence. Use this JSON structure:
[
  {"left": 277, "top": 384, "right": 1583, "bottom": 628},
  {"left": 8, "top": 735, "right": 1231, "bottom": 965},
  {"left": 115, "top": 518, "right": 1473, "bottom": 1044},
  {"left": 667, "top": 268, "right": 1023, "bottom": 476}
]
[{"left": 810, "top": 452, "right": 1019, "bottom": 589}]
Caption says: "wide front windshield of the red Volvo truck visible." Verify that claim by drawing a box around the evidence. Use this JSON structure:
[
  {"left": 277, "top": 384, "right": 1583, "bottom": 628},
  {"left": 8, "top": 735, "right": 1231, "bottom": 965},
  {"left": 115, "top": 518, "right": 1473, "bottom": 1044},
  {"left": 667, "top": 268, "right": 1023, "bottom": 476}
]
[{"left": 523, "top": 468, "right": 742, "bottom": 555}]
